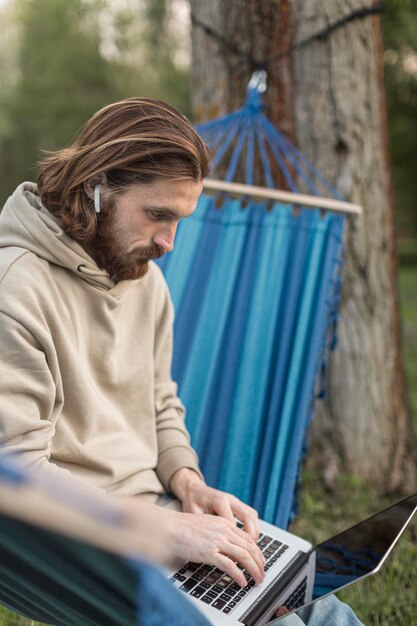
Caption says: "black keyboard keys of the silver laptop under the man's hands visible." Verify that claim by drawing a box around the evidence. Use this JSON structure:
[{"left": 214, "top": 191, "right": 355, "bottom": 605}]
[{"left": 171, "top": 524, "right": 288, "bottom": 613}]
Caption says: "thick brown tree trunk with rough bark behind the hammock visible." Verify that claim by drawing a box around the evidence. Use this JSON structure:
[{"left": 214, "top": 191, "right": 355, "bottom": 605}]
[{"left": 190, "top": 0, "right": 417, "bottom": 490}]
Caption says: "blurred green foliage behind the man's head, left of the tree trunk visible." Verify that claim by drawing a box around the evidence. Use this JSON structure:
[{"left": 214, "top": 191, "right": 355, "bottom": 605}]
[{"left": 0, "top": 0, "right": 190, "bottom": 204}]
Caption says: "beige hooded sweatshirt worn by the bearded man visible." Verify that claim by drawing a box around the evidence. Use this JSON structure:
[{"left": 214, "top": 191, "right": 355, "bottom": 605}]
[{"left": 0, "top": 183, "right": 202, "bottom": 495}]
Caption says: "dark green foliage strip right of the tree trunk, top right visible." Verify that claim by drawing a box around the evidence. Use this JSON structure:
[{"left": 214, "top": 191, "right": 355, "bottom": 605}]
[{"left": 382, "top": 0, "right": 417, "bottom": 237}]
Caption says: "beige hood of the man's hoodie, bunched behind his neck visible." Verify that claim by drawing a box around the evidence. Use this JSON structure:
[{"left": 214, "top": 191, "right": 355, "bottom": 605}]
[{"left": 0, "top": 182, "right": 117, "bottom": 291}]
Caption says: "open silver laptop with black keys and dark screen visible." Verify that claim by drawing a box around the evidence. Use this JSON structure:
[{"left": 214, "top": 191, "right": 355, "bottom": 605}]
[{"left": 169, "top": 494, "right": 417, "bottom": 626}]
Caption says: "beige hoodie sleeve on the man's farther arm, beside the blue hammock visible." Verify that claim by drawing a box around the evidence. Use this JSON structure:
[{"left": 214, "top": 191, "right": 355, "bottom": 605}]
[{"left": 155, "top": 277, "right": 202, "bottom": 491}]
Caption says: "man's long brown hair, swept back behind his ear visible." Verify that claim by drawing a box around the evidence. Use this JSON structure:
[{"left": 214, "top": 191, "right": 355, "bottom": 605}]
[{"left": 38, "top": 97, "right": 209, "bottom": 242}]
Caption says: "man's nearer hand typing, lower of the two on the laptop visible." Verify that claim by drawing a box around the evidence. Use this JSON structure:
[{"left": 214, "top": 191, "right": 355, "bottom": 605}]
[{"left": 161, "top": 509, "right": 265, "bottom": 587}]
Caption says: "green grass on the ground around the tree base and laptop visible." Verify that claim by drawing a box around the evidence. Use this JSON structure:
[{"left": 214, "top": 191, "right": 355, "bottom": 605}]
[{"left": 0, "top": 263, "right": 417, "bottom": 626}]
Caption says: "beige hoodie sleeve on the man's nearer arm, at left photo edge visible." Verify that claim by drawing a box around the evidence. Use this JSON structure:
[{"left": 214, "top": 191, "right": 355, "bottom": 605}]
[{"left": 0, "top": 311, "right": 102, "bottom": 493}]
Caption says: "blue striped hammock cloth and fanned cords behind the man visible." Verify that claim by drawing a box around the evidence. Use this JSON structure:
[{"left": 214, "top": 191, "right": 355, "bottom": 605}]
[{"left": 158, "top": 77, "right": 345, "bottom": 528}]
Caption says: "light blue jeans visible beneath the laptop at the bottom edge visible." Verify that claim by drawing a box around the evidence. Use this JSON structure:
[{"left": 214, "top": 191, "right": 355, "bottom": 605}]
[{"left": 271, "top": 596, "right": 363, "bottom": 626}]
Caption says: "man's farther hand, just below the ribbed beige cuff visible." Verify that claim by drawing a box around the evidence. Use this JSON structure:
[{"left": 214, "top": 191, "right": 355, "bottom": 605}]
[{"left": 170, "top": 467, "right": 259, "bottom": 541}]
